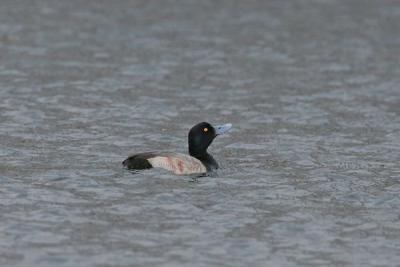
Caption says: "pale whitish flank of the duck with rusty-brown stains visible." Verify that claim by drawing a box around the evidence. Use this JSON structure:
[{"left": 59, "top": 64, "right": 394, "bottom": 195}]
[{"left": 148, "top": 153, "right": 207, "bottom": 175}]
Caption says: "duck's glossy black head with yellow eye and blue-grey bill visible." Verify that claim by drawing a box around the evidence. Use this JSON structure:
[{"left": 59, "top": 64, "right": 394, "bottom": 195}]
[{"left": 188, "top": 122, "right": 232, "bottom": 158}]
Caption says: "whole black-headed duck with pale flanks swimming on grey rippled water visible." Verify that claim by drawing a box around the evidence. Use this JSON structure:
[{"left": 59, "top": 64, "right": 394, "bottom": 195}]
[{"left": 122, "top": 122, "right": 232, "bottom": 175}]
